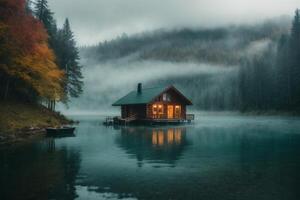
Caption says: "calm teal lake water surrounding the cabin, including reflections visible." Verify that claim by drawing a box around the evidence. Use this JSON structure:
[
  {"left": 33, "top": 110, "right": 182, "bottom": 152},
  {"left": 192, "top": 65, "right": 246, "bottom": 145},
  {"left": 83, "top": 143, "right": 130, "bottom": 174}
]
[{"left": 0, "top": 115, "right": 300, "bottom": 200}]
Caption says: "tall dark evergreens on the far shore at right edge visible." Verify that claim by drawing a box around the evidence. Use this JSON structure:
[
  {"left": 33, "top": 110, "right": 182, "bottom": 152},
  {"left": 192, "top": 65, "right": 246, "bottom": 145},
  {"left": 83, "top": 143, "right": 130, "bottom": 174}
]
[{"left": 239, "top": 9, "right": 300, "bottom": 112}]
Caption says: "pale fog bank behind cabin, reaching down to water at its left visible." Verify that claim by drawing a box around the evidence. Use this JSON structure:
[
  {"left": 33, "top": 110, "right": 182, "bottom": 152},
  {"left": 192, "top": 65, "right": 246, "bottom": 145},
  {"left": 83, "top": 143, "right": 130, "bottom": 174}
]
[{"left": 59, "top": 59, "right": 238, "bottom": 114}]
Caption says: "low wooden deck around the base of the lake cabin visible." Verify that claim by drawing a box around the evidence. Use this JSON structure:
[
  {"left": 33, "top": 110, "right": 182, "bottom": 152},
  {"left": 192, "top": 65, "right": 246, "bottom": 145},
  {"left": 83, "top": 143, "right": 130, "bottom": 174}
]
[{"left": 103, "top": 114, "right": 195, "bottom": 126}]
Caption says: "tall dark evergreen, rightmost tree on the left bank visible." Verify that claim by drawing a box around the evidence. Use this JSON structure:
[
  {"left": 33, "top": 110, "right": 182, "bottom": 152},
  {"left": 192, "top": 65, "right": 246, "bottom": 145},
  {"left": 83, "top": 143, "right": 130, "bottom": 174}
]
[{"left": 58, "top": 19, "right": 83, "bottom": 97}]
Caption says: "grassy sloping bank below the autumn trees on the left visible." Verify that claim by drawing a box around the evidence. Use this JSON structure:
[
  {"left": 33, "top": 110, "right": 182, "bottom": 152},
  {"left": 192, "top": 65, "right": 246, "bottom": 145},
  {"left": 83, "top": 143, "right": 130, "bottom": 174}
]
[{"left": 0, "top": 102, "right": 71, "bottom": 143}]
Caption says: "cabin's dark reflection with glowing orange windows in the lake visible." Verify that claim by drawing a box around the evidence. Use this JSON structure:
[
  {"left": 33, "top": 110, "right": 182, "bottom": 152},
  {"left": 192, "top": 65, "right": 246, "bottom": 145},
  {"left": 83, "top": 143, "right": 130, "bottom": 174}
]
[{"left": 116, "top": 127, "right": 188, "bottom": 167}]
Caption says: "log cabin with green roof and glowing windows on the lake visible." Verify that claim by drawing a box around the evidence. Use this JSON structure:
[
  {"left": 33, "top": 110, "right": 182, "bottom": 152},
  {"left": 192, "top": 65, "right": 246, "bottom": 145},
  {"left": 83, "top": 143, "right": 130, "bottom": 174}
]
[{"left": 112, "top": 83, "right": 194, "bottom": 122}]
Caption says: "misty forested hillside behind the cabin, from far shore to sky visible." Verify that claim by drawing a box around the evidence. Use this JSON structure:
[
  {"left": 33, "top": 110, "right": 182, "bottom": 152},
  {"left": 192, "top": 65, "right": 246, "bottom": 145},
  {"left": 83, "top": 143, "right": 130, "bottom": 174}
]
[{"left": 59, "top": 14, "right": 297, "bottom": 112}]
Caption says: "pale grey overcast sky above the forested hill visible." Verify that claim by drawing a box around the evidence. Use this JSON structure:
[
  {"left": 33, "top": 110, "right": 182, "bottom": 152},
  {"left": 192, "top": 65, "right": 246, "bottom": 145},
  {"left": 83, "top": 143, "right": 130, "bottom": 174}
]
[{"left": 48, "top": 0, "right": 300, "bottom": 45}]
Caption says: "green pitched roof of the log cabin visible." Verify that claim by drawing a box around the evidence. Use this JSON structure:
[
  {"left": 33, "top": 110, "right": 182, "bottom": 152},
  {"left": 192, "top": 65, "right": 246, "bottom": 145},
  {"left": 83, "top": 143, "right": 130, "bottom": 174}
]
[{"left": 112, "top": 86, "right": 192, "bottom": 106}]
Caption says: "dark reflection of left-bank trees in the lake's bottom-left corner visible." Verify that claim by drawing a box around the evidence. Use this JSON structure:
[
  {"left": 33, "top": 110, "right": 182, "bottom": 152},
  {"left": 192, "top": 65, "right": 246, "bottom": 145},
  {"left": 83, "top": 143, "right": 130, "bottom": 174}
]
[{"left": 0, "top": 139, "right": 81, "bottom": 199}]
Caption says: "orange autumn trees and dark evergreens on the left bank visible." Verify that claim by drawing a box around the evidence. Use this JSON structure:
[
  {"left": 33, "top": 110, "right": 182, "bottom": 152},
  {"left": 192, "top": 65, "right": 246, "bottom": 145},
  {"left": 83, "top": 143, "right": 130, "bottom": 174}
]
[{"left": 0, "top": 0, "right": 83, "bottom": 109}]
